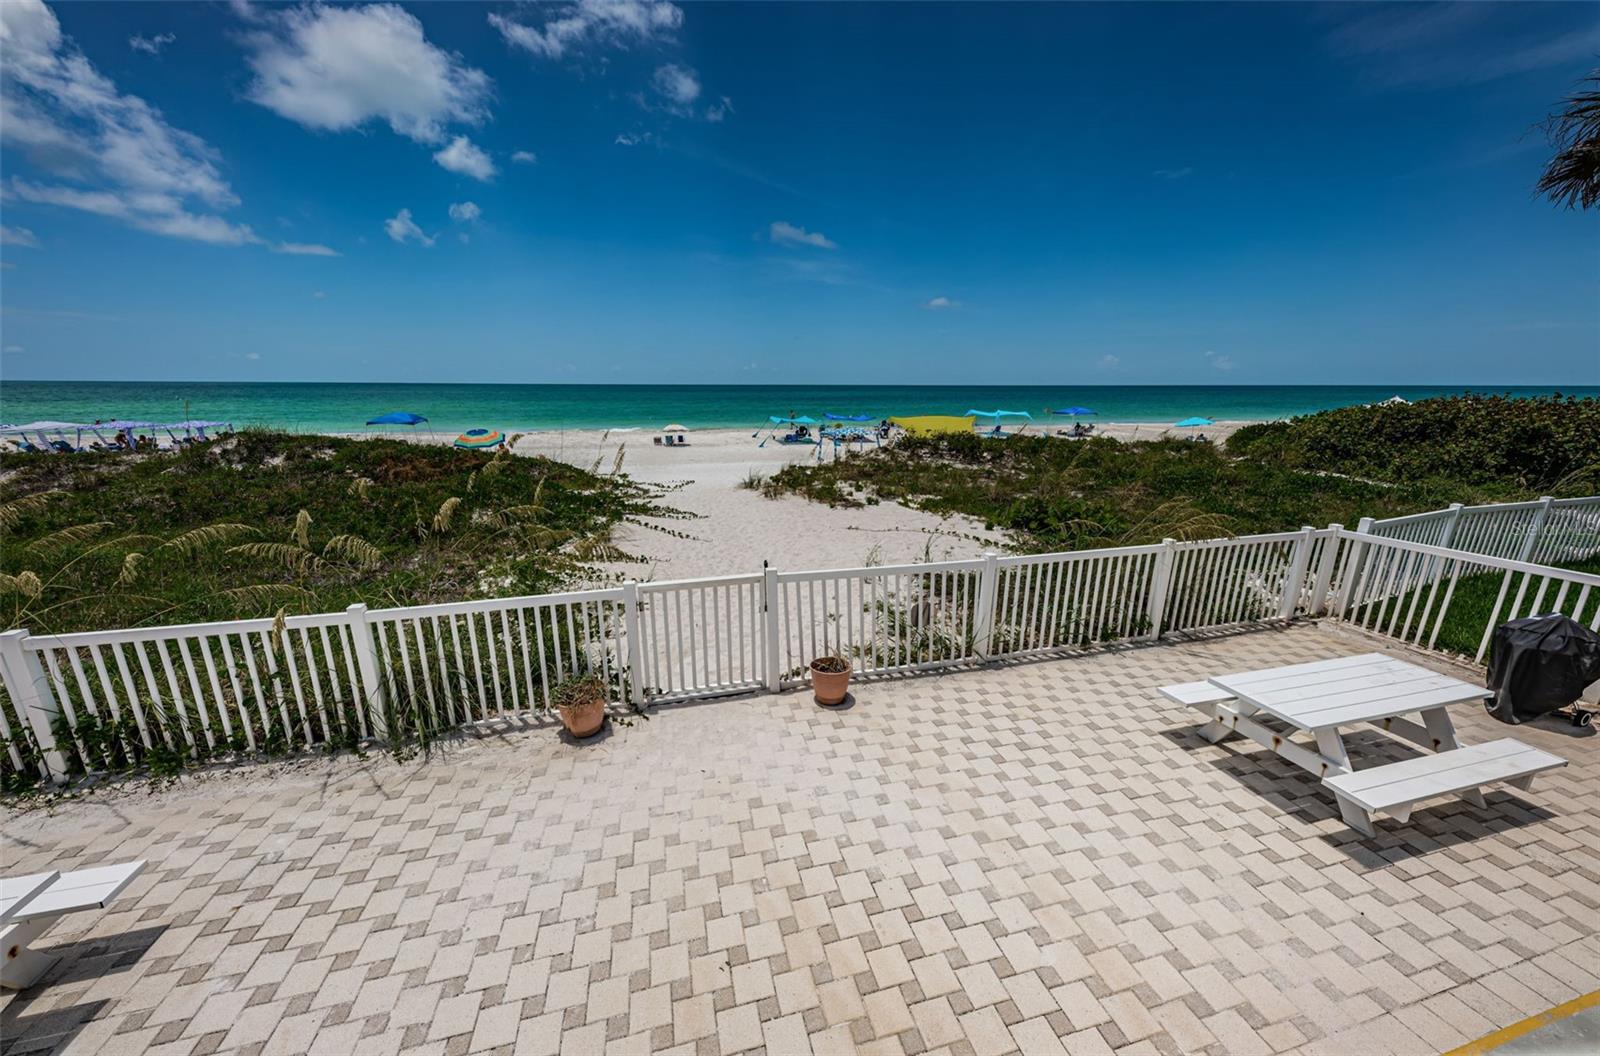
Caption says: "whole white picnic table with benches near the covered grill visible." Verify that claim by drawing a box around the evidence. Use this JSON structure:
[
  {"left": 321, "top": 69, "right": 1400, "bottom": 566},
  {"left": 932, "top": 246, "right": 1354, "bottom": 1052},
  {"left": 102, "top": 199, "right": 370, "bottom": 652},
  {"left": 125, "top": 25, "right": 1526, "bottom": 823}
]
[{"left": 1162, "top": 653, "right": 1566, "bottom": 835}]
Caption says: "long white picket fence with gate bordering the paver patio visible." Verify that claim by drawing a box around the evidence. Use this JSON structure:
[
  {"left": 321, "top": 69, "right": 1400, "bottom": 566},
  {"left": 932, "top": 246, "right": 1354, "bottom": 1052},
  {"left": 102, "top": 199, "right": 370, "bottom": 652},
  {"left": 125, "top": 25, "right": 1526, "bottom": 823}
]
[{"left": 0, "top": 504, "right": 1600, "bottom": 776}]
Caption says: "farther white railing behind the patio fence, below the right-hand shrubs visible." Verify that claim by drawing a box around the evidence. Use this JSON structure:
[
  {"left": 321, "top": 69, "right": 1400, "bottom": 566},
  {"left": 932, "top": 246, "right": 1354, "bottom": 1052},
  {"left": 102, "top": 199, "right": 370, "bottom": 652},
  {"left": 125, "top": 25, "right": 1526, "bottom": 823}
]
[{"left": 1362, "top": 496, "right": 1600, "bottom": 565}]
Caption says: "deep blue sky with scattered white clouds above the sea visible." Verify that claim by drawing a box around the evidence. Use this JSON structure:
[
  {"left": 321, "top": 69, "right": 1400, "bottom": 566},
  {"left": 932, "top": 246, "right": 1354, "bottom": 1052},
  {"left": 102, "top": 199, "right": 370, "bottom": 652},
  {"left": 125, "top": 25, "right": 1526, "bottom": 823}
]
[{"left": 0, "top": 0, "right": 1600, "bottom": 386}]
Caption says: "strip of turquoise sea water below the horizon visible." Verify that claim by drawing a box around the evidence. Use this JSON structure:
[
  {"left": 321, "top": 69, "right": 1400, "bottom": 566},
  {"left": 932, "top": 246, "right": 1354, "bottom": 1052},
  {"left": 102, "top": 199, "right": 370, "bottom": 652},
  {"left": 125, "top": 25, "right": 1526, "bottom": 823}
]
[{"left": 0, "top": 381, "right": 1600, "bottom": 432}]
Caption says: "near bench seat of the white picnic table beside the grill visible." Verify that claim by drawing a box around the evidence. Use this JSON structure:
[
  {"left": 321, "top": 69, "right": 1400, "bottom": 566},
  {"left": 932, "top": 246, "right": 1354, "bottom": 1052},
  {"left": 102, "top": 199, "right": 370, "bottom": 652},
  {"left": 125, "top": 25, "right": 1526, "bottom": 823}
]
[{"left": 1323, "top": 738, "right": 1566, "bottom": 835}]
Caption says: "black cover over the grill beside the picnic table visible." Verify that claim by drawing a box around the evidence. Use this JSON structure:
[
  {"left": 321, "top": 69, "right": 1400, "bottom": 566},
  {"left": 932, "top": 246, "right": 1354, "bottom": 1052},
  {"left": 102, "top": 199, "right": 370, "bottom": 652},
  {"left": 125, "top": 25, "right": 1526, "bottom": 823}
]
[{"left": 1488, "top": 613, "right": 1600, "bottom": 725}]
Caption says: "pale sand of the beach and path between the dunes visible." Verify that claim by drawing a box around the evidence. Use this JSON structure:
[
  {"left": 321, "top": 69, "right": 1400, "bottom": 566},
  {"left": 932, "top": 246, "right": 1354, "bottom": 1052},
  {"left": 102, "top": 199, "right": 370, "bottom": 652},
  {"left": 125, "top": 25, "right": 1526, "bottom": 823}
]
[{"left": 387, "top": 421, "right": 1250, "bottom": 581}]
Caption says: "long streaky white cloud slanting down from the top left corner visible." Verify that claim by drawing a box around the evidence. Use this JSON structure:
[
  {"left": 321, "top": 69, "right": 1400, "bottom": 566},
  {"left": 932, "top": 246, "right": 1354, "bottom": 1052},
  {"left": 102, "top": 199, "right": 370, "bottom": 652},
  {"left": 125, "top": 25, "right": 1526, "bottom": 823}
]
[{"left": 0, "top": 0, "right": 259, "bottom": 245}]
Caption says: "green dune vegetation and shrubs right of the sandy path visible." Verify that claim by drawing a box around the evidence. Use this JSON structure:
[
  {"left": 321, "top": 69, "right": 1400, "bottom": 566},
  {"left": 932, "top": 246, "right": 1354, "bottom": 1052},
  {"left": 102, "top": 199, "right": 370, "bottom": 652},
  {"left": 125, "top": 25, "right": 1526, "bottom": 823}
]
[{"left": 763, "top": 397, "right": 1600, "bottom": 552}]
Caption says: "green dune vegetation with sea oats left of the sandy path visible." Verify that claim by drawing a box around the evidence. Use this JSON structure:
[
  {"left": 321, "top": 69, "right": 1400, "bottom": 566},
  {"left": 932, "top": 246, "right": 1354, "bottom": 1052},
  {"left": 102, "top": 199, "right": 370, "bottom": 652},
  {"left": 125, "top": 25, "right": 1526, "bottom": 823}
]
[{"left": 0, "top": 432, "right": 661, "bottom": 634}]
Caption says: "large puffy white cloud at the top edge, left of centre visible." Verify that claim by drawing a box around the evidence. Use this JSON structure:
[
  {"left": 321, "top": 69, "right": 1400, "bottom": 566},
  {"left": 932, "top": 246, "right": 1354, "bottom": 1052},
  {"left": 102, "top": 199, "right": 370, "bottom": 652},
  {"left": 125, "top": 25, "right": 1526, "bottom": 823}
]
[{"left": 246, "top": 3, "right": 493, "bottom": 146}]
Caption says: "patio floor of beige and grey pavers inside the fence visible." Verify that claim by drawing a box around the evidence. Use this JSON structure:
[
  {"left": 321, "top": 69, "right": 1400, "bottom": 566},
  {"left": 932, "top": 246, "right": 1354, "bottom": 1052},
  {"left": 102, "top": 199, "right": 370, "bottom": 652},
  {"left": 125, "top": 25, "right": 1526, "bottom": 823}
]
[{"left": 0, "top": 627, "right": 1600, "bottom": 1056}]
